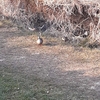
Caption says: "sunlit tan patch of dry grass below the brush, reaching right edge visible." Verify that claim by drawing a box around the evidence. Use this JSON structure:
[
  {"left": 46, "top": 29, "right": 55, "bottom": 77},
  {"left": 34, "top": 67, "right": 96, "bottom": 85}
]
[{"left": 6, "top": 30, "right": 100, "bottom": 77}]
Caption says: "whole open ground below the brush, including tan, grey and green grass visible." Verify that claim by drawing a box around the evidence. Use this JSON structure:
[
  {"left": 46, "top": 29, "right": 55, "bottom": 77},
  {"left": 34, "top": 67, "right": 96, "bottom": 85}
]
[{"left": 0, "top": 19, "right": 100, "bottom": 100}]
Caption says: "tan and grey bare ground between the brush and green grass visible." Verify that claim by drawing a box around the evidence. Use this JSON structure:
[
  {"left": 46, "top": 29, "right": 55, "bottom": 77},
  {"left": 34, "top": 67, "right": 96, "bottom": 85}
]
[{"left": 0, "top": 19, "right": 100, "bottom": 100}]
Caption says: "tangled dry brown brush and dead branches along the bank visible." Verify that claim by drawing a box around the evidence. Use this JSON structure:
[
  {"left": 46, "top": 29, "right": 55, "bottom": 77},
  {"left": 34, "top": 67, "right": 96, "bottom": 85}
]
[{"left": 0, "top": 0, "right": 100, "bottom": 44}]
